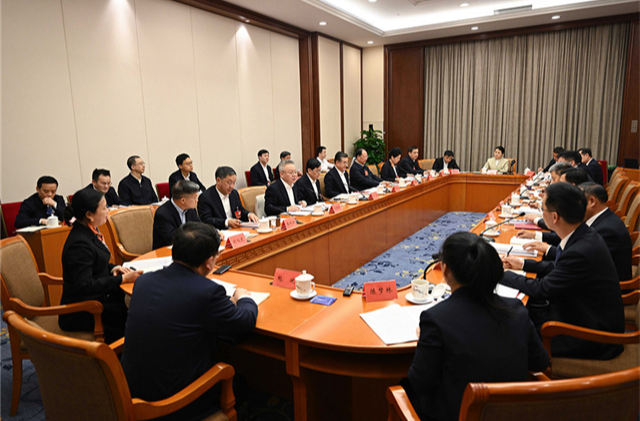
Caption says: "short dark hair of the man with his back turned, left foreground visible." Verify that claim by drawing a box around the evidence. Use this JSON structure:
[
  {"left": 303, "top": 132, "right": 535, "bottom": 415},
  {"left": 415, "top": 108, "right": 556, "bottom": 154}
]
[{"left": 171, "top": 222, "right": 220, "bottom": 268}]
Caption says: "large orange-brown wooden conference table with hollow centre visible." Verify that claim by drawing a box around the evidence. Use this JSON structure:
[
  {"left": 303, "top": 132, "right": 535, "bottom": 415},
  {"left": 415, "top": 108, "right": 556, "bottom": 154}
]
[{"left": 122, "top": 173, "right": 526, "bottom": 421}]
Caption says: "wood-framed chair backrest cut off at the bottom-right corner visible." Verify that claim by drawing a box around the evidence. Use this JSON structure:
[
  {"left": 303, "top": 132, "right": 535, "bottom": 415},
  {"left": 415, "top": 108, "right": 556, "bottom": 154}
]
[{"left": 459, "top": 367, "right": 640, "bottom": 421}]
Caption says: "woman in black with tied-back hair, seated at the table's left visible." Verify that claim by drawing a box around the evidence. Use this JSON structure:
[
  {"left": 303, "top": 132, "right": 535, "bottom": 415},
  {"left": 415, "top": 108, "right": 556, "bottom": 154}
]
[{"left": 58, "top": 189, "right": 142, "bottom": 343}]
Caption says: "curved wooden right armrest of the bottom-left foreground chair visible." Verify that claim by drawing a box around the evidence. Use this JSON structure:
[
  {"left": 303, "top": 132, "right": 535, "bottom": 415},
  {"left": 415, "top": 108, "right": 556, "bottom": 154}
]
[{"left": 132, "top": 363, "right": 235, "bottom": 420}]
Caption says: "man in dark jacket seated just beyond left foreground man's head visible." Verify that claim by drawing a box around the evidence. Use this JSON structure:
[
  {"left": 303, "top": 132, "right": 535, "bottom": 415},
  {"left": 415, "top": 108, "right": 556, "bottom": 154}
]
[{"left": 153, "top": 180, "right": 200, "bottom": 250}]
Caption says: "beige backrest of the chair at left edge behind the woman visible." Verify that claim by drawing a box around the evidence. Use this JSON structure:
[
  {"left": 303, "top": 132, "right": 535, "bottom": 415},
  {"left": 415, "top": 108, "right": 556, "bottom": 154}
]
[{"left": 0, "top": 235, "right": 45, "bottom": 311}]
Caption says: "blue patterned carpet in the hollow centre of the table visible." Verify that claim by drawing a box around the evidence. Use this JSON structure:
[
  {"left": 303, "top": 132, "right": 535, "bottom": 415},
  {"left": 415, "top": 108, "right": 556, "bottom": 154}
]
[{"left": 333, "top": 212, "right": 486, "bottom": 290}]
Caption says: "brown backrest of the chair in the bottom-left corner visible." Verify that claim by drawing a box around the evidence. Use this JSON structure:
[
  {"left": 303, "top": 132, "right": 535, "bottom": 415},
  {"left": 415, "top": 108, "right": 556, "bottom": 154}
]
[{"left": 5, "top": 312, "right": 134, "bottom": 421}]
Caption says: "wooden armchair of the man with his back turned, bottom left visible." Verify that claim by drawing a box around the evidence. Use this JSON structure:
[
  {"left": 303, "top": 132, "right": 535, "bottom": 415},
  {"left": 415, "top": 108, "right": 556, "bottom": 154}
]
[{"left": 3, "top": 311, "right": 237, "bottom": 421}]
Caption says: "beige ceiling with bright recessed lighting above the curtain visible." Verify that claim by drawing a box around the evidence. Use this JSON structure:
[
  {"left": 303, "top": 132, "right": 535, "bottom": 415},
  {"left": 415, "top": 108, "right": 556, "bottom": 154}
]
[{"left": 221, "top": 0, "right": 640, "bottom": 47}]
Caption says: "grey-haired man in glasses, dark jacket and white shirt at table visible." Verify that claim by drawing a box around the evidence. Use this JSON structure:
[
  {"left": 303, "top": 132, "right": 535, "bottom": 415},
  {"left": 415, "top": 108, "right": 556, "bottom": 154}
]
[{"left": 264, "top": 161, "right": 307, "bottom": 216}]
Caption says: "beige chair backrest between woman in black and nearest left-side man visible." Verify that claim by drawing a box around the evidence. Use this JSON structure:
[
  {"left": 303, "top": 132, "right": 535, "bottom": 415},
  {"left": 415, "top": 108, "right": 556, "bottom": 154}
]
[{"left": 107, "top": 206, "right": 153, "bottom": 254}]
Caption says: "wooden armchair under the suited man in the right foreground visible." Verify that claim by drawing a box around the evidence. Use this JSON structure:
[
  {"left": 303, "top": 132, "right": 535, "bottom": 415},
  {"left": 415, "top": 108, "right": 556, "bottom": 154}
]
[{"left": 540, "top": 304, "right": 640, "bottom": 378}]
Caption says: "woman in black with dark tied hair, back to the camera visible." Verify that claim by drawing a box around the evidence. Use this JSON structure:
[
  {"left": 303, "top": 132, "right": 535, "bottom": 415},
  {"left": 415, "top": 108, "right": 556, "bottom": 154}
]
[{"left": 402, "top": 232, "right": 549, "bottom": 420}]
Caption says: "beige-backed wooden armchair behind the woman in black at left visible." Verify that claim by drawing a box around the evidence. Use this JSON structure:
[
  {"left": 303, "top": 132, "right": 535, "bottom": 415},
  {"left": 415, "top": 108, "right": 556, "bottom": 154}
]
[{"left": 0, "top": 236, "right": 104, "bottom": 416}]
